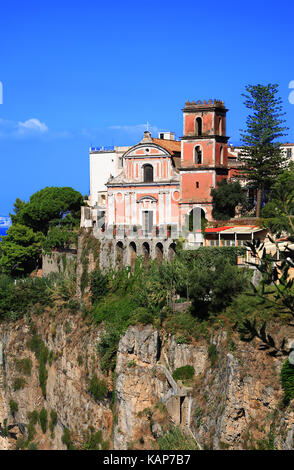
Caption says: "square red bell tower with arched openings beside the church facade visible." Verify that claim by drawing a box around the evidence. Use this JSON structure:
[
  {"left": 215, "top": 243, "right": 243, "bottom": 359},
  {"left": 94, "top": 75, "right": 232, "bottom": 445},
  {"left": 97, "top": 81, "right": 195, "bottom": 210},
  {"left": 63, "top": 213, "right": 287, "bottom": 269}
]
[{"left": 180, "top": 100, "right": 229, "bottom": 220}]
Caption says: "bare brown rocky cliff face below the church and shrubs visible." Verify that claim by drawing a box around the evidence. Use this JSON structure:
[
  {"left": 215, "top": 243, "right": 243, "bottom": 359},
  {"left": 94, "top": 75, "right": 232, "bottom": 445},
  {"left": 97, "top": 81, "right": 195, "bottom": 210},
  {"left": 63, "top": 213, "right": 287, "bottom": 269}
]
[{"left": 0, "top": 313, "right": 294, "bottom": 449}]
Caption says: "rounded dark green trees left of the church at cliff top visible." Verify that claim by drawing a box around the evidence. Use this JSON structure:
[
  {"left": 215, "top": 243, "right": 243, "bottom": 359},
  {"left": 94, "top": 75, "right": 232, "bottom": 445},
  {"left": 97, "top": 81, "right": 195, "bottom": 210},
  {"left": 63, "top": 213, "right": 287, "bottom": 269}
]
[{"left": 0, "top": 187, "right": 84, "bottom": 277}]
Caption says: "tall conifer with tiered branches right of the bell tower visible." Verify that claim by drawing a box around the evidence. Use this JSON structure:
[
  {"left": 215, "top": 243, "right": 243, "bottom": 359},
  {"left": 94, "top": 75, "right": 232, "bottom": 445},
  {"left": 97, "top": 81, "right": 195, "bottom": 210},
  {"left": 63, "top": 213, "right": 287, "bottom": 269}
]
[{"left": 240, "top": 83, "right": 288, "bottom": 217}]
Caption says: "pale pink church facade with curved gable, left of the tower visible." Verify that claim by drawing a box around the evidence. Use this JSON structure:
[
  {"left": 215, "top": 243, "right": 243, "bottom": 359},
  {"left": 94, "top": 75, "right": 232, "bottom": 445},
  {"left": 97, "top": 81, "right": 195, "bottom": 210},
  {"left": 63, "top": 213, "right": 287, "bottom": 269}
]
[{"left": 106, "top": 131, "right": 181, "bottom": 234}]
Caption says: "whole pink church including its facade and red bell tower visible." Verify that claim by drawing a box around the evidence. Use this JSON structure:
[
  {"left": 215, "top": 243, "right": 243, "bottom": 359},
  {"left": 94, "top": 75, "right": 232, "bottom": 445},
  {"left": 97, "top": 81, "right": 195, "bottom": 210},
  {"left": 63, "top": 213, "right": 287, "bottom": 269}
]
[{"left": 81, "top": 100, "right": 229, "bottom": 246}]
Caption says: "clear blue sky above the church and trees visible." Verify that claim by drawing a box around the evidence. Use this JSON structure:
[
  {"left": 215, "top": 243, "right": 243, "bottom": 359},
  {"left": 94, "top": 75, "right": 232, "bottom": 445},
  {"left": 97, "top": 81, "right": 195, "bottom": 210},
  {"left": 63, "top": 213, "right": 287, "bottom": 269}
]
[{"left": 0, "top": 0, "right": 294, "bottom": 215}]
